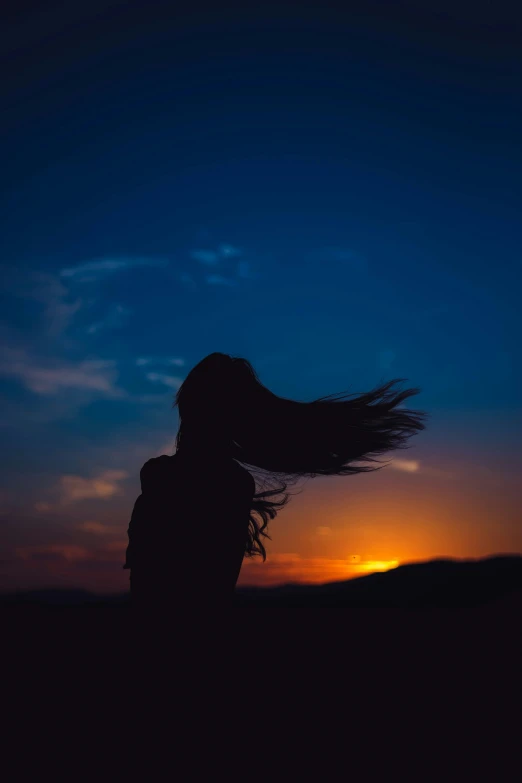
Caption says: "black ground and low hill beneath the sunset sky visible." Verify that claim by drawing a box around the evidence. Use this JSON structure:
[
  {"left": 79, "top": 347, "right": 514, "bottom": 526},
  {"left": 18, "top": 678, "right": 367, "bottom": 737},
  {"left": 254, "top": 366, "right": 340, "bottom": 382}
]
[{"left": 0, "top": 556, "right": 522, "bottom": 756}]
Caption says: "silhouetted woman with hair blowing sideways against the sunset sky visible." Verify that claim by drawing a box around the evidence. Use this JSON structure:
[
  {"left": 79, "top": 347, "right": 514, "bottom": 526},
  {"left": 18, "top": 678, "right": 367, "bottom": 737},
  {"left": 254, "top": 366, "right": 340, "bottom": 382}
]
[{"left": 123, "top": 353, "right": 427, "bottom": 610}]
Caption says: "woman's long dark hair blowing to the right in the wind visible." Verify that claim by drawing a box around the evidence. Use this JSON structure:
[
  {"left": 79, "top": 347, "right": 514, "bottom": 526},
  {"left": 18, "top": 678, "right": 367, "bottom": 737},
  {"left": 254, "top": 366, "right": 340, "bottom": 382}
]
[{"left": 173, "top": 353, "right": 428, "bottom": 561}]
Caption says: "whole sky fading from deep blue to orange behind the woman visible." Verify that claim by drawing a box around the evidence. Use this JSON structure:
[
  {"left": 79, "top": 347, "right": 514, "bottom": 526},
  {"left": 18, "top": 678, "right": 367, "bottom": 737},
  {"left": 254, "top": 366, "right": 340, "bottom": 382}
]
[{"left": 0, "top": 2, "right": 522, "bottom": 592}]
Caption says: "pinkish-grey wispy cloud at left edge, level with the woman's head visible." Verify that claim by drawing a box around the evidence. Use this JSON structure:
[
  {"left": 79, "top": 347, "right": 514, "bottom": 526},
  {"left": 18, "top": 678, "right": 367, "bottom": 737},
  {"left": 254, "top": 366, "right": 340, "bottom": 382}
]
[{"left": 0, "top": 347, "right": 126, "bottom": 398}]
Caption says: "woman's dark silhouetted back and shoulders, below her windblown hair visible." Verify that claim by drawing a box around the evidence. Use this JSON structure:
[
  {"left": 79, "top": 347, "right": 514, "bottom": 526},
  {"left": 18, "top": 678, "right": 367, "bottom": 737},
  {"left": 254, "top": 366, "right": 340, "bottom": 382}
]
[{"left": 125, "top": 452, "right": 255, "bottom": 608}]
